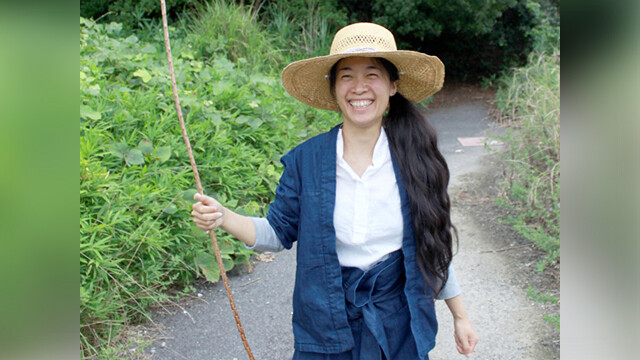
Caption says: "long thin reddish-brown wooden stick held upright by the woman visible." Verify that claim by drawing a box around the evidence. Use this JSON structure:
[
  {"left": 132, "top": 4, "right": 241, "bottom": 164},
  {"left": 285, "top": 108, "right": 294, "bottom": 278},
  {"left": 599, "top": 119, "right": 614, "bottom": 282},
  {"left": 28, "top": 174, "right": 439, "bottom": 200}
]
[{"left": 160, "top": 0, "right": 255, "bottom": 360}]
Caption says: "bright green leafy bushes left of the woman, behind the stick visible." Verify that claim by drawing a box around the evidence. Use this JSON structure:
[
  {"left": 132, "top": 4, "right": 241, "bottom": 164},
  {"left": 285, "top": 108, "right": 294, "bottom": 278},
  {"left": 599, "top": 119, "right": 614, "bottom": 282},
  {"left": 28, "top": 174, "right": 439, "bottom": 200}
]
[{"left": 80, "top": 18, "right": 337, "bottom": 356}]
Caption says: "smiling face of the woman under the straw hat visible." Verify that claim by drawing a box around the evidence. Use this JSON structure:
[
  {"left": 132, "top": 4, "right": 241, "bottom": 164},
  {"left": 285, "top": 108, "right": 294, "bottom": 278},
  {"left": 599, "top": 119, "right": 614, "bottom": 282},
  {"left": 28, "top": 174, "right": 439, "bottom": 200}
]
[{"left": 335, "top": 56, "right": 397, "bottom": 127}]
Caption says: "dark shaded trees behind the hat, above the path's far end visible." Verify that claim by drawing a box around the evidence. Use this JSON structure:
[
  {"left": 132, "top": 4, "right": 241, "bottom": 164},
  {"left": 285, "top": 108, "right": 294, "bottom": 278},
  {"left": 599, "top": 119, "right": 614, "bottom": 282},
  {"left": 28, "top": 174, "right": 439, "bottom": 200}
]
[{"left": 344, "top": 0, "right": 548, "bottom": 80}]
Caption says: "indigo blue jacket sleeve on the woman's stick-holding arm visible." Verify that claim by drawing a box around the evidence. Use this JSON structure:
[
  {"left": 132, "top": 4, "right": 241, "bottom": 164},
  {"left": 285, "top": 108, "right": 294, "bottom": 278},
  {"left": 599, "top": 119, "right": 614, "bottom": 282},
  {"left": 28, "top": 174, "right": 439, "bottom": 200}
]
[{"left": 267, "top": 149, "right": 300, "bottom": 249}]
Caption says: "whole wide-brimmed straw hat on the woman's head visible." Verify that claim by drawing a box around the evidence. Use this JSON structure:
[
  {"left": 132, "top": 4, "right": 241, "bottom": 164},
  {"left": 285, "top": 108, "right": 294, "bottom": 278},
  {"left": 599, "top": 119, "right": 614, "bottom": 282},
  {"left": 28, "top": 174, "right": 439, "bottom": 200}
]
[{"left": 282, "top": 23, "right": 444, "bottom": 111}]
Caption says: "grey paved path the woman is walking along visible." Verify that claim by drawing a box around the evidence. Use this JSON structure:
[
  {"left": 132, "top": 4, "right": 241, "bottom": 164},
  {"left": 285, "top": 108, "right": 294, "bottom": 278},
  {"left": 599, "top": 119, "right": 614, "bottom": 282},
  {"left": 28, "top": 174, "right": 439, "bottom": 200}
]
[{"left": 146, "top": 86, "right": 559, "bottom": 360}]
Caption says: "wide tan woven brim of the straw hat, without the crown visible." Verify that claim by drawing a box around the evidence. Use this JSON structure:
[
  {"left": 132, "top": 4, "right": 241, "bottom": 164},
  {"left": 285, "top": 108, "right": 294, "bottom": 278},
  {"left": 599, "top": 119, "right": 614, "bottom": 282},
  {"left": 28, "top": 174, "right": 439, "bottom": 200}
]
[{"left": 282, "top": 50, "right": 444, "bottom": 111}]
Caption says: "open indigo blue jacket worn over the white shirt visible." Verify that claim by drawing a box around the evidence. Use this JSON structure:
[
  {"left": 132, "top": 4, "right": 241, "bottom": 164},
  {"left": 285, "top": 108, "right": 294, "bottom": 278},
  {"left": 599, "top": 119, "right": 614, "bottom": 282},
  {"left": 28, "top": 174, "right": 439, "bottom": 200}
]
[{"left": 267, "top": 125, "right": 438, "bottom": 358}]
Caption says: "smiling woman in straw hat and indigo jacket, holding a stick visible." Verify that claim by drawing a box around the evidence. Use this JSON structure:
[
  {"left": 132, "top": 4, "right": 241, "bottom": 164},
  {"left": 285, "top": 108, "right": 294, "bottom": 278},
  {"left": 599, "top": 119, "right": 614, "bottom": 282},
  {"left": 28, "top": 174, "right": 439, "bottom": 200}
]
[{"left": 192, "top": 23, "right": 478, "bottom": 360}]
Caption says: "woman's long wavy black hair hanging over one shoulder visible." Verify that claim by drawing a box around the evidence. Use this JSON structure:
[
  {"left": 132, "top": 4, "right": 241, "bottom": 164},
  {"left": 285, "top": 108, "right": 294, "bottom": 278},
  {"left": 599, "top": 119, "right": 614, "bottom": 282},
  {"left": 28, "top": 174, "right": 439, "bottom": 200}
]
[{"left": 330, "top": 58, "right": 457, "bottom": 296}]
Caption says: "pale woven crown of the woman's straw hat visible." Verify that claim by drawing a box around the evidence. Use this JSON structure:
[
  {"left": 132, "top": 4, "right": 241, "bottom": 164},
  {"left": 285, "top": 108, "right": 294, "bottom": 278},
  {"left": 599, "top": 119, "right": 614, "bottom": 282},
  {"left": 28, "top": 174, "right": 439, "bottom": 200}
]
[{"left": 329, "top": 23, "right": 397, "bottom": 55}]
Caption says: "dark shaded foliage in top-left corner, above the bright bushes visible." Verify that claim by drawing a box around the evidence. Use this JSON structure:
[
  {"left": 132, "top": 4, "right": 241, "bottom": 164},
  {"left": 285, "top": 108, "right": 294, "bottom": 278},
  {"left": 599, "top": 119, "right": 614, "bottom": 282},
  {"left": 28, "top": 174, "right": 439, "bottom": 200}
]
[{"left": 80, "top": 0, "right": 202, "bottom": 29}]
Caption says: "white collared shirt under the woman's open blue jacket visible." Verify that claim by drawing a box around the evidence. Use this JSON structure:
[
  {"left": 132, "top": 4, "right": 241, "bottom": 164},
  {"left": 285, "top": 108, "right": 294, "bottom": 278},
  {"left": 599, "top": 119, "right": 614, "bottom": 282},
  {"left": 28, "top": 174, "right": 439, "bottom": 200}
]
[{"left": 333, "top": 129, "right": 403, "bottom": 270}]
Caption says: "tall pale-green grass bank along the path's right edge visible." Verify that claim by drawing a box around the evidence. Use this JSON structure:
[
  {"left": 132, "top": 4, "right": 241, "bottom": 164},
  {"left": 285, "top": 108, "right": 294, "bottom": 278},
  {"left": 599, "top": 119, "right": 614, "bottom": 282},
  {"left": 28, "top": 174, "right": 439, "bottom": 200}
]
[{"left": 497, "top": 39, "right": 560, "bottom": 271}]
